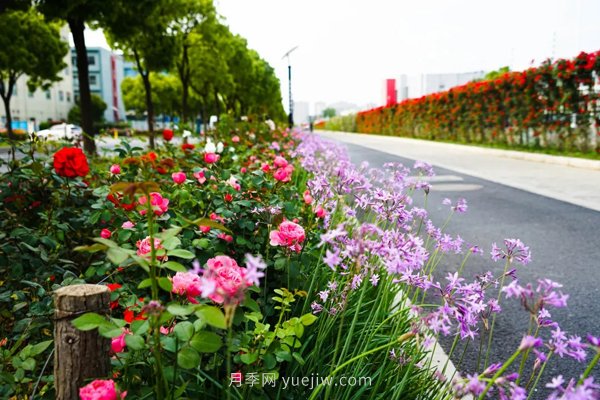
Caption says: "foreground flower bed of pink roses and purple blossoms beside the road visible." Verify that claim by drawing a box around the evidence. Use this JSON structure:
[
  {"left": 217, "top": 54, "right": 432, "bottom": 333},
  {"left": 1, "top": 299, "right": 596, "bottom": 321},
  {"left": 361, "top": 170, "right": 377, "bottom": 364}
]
[{"left": 0, "top": 126, "right": 600, "bottom": 399}]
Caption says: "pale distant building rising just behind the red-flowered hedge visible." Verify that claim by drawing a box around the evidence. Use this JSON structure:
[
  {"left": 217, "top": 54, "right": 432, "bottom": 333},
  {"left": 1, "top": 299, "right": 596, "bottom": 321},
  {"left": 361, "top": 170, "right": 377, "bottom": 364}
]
[{"left": 394, "top": 71, "right": 485, "bottom": 101}]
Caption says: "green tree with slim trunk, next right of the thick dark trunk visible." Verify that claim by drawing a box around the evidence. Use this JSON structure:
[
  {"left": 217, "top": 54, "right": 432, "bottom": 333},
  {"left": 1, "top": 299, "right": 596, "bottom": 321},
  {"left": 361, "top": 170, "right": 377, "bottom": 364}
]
[{"left": 105, "top": 0, "right": 176, "bottom": 148}]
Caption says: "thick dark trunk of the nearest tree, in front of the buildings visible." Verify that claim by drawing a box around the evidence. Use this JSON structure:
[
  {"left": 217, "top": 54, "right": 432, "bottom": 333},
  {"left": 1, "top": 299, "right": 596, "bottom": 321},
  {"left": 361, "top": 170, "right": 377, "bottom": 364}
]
[{"left": 67, "top": 18, "right": 96, "bottom": 155}]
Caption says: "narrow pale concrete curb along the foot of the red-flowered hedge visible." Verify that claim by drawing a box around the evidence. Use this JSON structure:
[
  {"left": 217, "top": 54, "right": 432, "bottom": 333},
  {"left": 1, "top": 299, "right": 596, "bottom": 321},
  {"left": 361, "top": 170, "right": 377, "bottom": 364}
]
[{"left": 321, "top": 131, "right": 600, "bottom": 171}]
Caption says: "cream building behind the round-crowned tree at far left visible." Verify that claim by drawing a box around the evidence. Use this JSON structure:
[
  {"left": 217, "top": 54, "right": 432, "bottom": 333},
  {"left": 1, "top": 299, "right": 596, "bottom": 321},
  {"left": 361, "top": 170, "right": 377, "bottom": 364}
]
[{"left": 0, "top": 26, "right": 75, "bottom": 132}]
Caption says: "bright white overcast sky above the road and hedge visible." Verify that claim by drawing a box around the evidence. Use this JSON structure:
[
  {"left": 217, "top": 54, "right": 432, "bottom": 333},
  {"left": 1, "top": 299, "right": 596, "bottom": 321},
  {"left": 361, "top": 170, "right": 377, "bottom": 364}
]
[{"left": 84, "top": 0, "right": 600, "bottom": 109}]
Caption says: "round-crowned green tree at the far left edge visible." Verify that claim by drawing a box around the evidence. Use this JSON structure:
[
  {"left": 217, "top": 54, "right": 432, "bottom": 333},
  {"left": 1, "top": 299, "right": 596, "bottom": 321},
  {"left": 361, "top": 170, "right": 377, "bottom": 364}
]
[{"left": 0, "top": 9, "right": 69, "bottom": 143}]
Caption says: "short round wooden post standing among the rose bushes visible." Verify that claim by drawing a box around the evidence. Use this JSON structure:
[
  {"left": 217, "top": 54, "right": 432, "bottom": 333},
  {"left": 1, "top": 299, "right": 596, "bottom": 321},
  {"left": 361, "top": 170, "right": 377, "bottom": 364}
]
[{"left": 54, "top": 285, "right": 110, "bottom": 400}]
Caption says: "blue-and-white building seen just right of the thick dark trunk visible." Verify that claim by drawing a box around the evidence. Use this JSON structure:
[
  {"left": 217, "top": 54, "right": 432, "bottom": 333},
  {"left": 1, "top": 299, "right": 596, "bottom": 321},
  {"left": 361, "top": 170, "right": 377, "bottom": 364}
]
[{"left": 71, "top": 47, "right": 125, "bottom": 122}]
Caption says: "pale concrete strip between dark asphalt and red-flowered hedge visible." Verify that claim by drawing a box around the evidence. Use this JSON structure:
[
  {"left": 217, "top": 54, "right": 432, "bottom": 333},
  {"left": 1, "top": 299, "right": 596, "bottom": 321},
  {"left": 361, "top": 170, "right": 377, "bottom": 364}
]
[{"left": 317, "top": 131, "right": 600, "bottom": 211}]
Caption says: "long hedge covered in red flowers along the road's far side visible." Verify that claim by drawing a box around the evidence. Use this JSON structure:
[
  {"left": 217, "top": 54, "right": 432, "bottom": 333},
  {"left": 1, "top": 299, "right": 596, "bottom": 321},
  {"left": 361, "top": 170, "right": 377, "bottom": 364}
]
[{"left": 325, "top": 52, "right": 600, "bottom": 154}]
